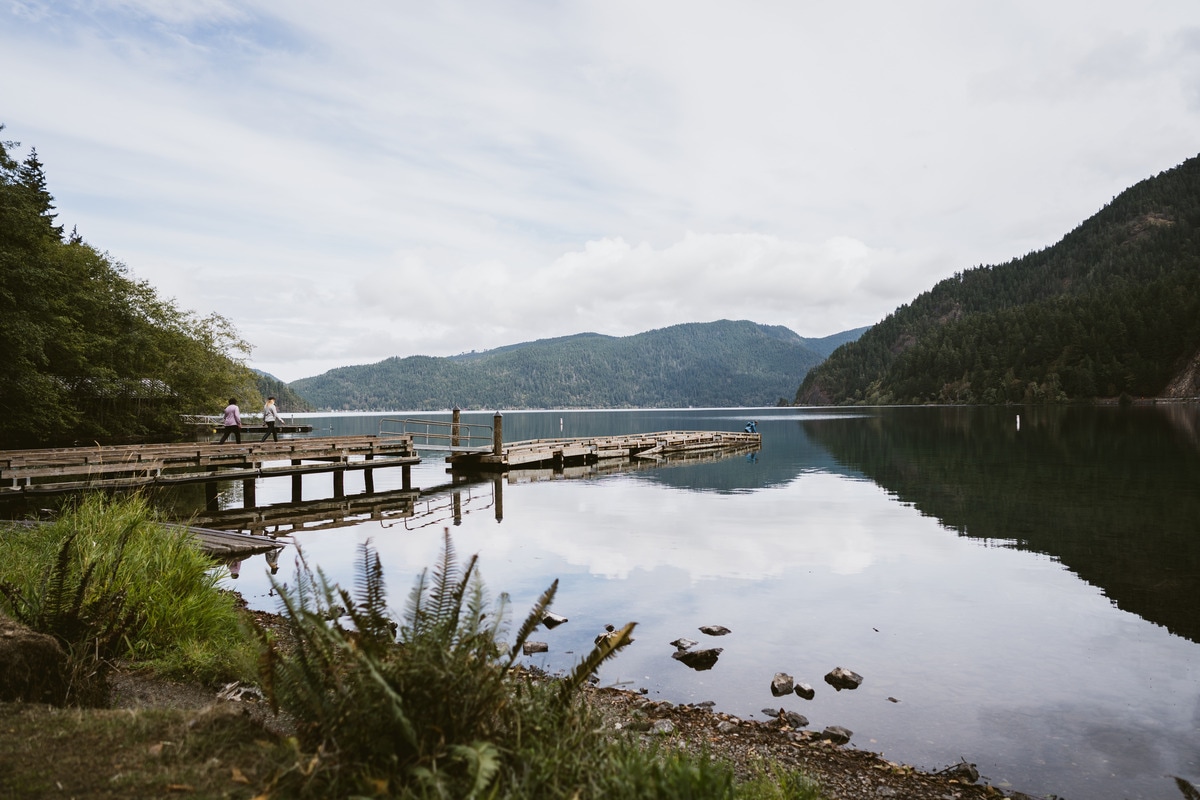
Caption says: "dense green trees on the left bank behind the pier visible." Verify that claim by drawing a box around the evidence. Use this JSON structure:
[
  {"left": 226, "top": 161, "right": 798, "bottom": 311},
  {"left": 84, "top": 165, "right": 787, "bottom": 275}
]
[{"left": 0, "top": 126, "right": 254, "bottom": 450}]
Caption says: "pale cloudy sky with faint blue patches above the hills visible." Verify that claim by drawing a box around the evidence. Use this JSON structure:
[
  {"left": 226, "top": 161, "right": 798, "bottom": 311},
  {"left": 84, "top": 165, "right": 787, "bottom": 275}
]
[{"left": 0, "top": 0, "right": 1200, "bottom": 380}]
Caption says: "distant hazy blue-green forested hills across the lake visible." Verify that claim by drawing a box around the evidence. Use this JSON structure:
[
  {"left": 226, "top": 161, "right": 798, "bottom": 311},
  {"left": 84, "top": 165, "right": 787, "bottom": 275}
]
[{"left": 288, "top": 320, "right": 853, "bottom": 410}]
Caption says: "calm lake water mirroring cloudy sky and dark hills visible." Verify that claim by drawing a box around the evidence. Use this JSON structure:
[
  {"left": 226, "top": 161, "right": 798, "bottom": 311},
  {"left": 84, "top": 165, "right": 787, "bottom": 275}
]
[{"left": 218, "top": 405, "right": 1200, "bottom": 800}]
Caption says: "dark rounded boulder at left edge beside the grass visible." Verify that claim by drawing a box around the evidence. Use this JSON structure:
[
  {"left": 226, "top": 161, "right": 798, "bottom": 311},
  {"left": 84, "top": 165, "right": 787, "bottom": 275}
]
[{"left": 0, "top": 615, "right": 67, "bottom": 703}]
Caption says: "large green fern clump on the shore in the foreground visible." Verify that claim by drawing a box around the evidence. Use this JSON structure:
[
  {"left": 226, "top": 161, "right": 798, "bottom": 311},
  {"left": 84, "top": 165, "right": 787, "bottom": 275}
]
[{"left": 263, "top": 530, "right": 632, "bottom": 798}]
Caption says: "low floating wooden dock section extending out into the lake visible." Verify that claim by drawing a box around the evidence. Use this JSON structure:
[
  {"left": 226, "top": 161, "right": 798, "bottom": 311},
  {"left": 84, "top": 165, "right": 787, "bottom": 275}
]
[{"left": 446, "top": 431, "right": 762, "bottom": 471}]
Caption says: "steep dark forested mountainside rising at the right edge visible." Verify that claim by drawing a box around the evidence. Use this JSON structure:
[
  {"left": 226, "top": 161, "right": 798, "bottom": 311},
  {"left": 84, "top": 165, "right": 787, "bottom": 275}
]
[{"left": 796, "top": 151, "right": 1200, "bottom": 404}]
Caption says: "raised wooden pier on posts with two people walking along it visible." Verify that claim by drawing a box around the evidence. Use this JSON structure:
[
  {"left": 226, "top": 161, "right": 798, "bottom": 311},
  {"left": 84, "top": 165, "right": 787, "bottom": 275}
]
[{"left": 0, "top": 435, "right": 420, "bottom": 505}]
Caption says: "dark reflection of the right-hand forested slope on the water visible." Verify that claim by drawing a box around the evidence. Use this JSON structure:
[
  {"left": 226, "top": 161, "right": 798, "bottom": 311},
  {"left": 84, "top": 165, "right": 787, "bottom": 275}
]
[{"left": 802, "top": 405, "right": 1200, "bottom": 642}]
